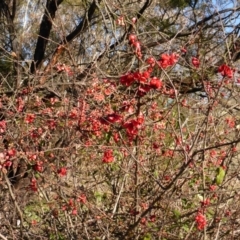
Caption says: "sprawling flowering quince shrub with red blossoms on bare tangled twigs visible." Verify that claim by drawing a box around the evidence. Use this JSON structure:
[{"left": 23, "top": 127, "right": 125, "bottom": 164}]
[{"left": 0, "top": 2, "right": 240, "bottom": 239}]
